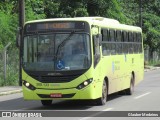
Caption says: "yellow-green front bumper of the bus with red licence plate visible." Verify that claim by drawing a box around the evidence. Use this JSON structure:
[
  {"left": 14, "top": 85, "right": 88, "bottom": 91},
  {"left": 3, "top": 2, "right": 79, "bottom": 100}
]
[{"left": 23, "top": 85, "right": 99, "bottom": 100}]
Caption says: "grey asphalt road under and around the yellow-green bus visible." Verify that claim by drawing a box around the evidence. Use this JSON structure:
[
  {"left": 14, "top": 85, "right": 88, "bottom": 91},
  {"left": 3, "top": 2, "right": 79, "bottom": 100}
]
[{"left": 0, "top": 69, "right": 160, "bottom": 118}]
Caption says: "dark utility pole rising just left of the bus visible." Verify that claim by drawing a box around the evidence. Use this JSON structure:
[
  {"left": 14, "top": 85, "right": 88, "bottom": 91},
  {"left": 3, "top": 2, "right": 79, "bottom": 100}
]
[{"left": 18, "top": 0, "right": 25, "bottom": 86}]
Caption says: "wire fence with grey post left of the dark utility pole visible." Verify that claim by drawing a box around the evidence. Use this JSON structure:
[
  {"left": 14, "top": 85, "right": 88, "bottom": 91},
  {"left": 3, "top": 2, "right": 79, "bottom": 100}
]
[{"left": 0, "top": 49, "right": 19, "bottom": 86}]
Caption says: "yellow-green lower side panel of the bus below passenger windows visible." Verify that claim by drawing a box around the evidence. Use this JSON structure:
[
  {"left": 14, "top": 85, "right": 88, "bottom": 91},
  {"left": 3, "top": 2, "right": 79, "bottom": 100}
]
[{"left": 101, "top": 54, "right": 144, "bottom": 94}]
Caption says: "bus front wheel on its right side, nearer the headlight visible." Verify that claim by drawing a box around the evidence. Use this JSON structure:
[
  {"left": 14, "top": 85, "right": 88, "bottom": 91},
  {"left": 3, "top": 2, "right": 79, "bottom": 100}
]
[{"left": 97, "top": 80, "right": 108, "bottom": 105}]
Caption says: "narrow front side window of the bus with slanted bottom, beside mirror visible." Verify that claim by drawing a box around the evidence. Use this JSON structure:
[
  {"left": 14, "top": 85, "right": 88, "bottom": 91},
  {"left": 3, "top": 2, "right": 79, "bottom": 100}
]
[{"left": 93, "top": 35, "right": 100, "bottom": 67}]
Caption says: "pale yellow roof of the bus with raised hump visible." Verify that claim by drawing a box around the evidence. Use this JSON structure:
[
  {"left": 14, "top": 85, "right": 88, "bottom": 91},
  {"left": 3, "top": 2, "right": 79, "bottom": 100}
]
[{"left": 26, "top": 17, "right": 142, "bottom": 32}]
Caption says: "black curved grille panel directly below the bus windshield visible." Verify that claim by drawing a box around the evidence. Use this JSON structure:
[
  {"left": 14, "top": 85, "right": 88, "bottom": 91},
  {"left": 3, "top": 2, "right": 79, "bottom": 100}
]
[{"left": 32, "top": 75, "right": 79, "bottom": 83}]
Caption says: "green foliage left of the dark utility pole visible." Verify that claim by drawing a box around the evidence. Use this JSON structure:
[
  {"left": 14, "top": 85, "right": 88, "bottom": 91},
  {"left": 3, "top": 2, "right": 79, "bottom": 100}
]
[{"left": 0, "top": 1, "right": 18, "bottom": 86}]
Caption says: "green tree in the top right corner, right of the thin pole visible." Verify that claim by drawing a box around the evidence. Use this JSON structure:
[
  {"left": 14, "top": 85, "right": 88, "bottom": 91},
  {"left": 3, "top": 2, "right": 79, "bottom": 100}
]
[{"left": 143, "top": 0, "right": 160, "bottom": 56}]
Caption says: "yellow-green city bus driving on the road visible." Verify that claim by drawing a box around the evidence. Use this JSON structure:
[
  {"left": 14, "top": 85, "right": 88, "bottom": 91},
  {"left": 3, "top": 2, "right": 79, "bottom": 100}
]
[{"left": 20, "top": 17, "right": 144, "bottom": 106}]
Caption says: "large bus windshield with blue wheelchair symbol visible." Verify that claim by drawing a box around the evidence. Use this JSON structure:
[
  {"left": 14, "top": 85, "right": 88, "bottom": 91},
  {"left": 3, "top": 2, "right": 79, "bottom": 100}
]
[{"left": 22, "top": 33, "right": 91, "bottom": 71}]
